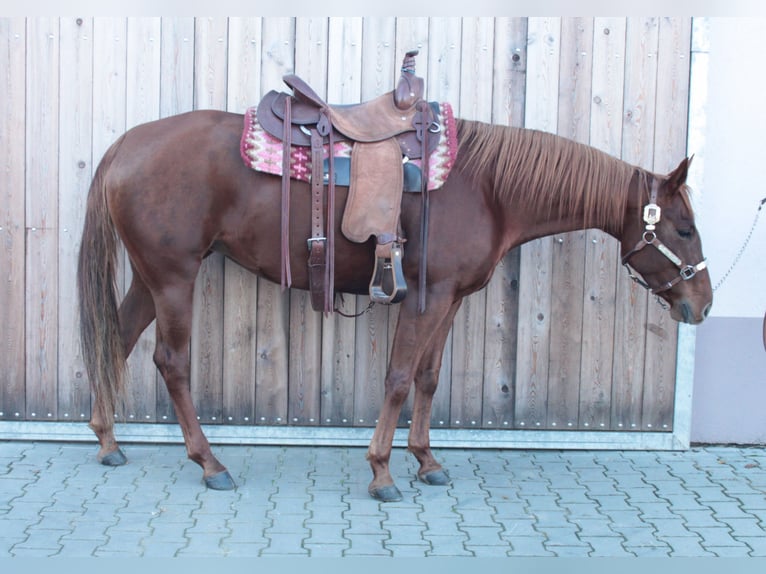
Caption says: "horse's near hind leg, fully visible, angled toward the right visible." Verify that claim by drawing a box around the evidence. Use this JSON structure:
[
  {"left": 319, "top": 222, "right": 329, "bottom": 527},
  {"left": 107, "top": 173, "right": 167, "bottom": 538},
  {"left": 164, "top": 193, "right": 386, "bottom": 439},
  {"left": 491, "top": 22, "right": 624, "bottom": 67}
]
[{"left": 154, "top": 281, "right": 236, "bottom": 490}]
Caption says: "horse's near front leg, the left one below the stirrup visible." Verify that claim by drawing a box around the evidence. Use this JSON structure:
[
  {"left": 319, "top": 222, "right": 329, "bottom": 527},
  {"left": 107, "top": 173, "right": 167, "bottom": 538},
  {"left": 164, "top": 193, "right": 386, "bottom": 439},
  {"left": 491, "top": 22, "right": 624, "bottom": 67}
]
[{"left": 367, "top": 296, "right": 450, "bottom": 502}]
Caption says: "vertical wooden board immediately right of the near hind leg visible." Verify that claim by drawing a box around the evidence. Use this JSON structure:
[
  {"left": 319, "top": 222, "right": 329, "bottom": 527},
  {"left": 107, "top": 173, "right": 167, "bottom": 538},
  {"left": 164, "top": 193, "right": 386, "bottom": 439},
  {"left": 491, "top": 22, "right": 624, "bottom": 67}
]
[{"left": 191, "top": 18, "right": 228, "bottom": 423}]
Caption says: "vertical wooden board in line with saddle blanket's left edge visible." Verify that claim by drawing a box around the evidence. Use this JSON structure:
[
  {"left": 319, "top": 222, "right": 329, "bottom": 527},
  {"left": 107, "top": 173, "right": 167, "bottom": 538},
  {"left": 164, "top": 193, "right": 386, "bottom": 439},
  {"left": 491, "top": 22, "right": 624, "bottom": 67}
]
[{"left": 223, "top": 18, "right": 262, "bottom": 424}]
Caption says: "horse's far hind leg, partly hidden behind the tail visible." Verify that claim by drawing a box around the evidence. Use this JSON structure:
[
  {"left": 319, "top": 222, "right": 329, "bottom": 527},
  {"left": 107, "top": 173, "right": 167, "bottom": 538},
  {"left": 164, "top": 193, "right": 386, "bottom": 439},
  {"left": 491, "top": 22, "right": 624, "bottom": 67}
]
[{"left": 90, "top": 272, "right": 154, "bottom": 466}]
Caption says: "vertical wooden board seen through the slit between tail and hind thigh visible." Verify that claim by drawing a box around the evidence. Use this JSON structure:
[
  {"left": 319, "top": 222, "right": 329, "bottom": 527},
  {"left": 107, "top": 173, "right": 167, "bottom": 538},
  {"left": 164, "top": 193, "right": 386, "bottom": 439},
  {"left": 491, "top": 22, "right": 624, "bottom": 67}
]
[{"left": 123, "top": 18, "right": 164, "bottom": 422}]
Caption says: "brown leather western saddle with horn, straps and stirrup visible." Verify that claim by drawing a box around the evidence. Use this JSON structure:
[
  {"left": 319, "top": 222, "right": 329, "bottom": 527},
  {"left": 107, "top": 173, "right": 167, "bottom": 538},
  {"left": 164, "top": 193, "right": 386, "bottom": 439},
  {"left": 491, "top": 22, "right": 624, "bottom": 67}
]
[{"left": 257, "top": 50, "right": 441, "bottom": 313}]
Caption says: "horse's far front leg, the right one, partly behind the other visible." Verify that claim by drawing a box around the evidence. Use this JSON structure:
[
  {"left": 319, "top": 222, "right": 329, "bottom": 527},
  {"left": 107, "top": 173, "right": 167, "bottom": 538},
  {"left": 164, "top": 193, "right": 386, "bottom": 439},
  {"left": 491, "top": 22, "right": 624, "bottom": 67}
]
[{"left": 407, "top": 300, "right": 462, "bottom": 486}]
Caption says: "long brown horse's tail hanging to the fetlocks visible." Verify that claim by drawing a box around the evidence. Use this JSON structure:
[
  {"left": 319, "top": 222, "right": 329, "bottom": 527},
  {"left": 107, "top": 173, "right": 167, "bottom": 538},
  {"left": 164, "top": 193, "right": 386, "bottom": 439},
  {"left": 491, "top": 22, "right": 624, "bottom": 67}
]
[{"left": 77, "top": 138, "right": 127, "bottom": 426}]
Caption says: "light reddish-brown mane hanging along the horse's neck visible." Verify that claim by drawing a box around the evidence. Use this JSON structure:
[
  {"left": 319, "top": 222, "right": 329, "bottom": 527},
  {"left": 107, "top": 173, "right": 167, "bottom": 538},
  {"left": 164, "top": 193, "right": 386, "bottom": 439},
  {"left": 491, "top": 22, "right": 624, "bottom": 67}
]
[{"left": 457, "top": 120, "right": 651, "bottom": 229}]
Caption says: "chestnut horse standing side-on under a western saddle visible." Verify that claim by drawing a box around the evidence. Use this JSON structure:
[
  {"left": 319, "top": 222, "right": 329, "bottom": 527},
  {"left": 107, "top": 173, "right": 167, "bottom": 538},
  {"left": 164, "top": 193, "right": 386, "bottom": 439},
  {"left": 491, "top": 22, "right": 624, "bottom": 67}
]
[{"left": 78, "top": 111, "right": 712, "bottom": 501}]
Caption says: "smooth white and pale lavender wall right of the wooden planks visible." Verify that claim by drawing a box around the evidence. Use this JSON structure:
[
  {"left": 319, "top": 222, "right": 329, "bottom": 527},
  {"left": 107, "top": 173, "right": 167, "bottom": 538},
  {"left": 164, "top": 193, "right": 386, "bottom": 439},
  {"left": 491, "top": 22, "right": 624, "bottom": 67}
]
[{"left": 689, "top": 18, "right": 766, "bottom": 444}]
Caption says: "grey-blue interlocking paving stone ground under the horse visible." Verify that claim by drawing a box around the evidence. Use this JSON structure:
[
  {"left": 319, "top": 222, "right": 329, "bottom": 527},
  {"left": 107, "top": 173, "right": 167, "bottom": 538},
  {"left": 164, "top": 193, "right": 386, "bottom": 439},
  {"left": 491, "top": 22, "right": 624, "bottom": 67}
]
[{"left": 0, "top": 442, "right": 766, "bottom": 558}]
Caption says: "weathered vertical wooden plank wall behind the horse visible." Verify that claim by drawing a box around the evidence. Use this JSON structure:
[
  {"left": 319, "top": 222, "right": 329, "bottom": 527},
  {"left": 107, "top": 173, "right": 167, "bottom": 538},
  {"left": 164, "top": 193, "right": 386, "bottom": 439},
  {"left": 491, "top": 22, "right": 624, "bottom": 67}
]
[{"left": 0, "top": 17, "right": 691, "bottom": 438}]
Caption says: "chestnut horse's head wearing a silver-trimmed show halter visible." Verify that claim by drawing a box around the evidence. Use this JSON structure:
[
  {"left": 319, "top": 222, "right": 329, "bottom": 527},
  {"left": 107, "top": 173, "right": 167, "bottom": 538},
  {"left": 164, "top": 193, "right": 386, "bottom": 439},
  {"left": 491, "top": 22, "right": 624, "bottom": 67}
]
[{"left": 622, "top": 158, "right": 713, "bottom": 325}]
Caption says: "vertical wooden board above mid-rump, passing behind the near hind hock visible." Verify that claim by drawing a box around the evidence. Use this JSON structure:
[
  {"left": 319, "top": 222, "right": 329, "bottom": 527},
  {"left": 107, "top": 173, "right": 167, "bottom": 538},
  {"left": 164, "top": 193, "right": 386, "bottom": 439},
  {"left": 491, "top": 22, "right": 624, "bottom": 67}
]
[{"left": 157, "top": 17, "right": 194, "bottom": 422}]
